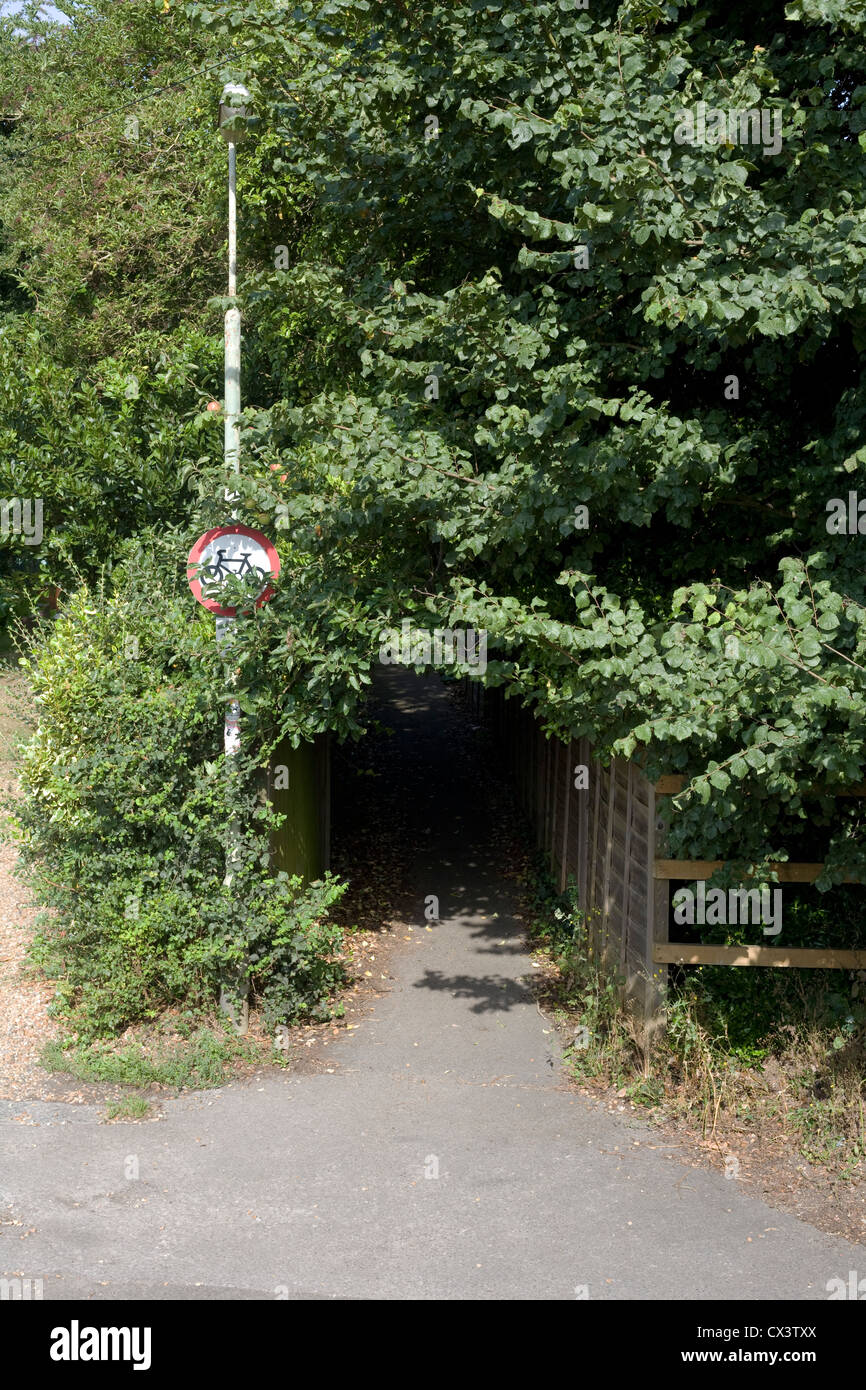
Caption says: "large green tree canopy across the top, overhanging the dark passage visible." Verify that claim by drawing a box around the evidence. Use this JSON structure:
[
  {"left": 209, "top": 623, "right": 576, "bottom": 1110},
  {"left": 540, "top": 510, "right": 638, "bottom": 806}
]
[{"left": 0, "top": 0, "right": 866, "bottom": 881}]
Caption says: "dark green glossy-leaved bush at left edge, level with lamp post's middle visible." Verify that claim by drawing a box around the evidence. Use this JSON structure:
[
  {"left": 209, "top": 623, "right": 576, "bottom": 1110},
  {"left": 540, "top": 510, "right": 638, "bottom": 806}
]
[{"left": 0, "top": 318, "right": 222, "bottom": 624}]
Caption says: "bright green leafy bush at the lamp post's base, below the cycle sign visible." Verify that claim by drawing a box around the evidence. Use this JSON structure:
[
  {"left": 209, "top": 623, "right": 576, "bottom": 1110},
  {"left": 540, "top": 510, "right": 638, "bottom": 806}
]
[{"left": 18, "top": 534, "right": 343, "bottom": 1036}]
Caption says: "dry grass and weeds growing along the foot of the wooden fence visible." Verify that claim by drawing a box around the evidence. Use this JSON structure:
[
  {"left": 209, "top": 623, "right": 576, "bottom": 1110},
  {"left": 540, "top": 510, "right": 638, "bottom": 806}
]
[{"left": 525, "top": 850, "right": 866, "bottom": 1177}]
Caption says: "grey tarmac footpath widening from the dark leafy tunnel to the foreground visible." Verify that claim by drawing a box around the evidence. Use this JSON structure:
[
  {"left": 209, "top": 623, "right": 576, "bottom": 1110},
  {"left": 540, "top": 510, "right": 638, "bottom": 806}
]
[{"left": 0, "top": 673, "right": 863, "bottom": 1300}]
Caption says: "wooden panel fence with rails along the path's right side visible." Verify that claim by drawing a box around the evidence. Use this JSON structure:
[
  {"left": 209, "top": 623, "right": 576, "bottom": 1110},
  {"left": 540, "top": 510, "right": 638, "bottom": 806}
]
[{"left": 464, "top": 681, "right": 866, "bottom": 1017}]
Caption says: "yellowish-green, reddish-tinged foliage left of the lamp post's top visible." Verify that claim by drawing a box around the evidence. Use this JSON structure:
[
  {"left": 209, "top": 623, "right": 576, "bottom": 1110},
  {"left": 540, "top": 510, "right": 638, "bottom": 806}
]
[{"left": 0, "top": 0, "right": 225, "bottom": 366}]
